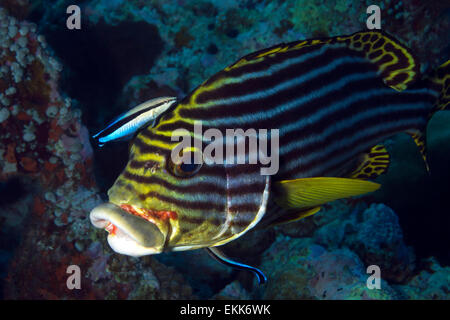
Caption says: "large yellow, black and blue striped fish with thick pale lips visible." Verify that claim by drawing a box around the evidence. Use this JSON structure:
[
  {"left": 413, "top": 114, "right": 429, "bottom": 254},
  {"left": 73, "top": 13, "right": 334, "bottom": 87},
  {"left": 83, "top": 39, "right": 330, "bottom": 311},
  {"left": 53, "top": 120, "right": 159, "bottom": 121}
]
[{"left": 90, "top": 31, "right": 450, "bottom": 283}]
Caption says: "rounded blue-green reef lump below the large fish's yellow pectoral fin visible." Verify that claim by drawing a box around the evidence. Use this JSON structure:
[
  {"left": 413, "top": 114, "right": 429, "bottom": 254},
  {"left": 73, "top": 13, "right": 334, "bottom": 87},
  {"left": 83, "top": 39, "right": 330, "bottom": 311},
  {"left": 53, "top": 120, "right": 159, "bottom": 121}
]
[{"left": 260, "top": 236, "right": 396, "bottom": 299}]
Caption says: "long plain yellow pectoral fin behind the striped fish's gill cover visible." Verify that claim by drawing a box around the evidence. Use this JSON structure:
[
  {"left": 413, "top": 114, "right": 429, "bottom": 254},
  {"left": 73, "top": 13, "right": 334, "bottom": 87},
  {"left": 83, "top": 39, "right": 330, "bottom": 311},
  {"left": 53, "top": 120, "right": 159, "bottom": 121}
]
[{"left": 274, "top": 177, "right": 380, "bottom": 209}]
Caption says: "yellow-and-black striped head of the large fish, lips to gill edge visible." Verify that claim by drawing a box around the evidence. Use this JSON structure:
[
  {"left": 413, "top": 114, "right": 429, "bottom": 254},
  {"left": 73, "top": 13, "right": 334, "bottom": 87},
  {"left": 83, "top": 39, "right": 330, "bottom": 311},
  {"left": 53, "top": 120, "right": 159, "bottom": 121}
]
[{"left": 90, "top": 122, "right": 268, "bottom": 256}]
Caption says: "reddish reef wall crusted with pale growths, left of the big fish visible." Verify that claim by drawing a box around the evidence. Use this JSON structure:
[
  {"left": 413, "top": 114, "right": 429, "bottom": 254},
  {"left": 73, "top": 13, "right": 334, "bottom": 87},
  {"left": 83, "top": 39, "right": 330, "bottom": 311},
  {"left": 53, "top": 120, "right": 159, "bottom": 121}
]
[{"left": 0, "top": 9, "right": 193, "bottom": 299}]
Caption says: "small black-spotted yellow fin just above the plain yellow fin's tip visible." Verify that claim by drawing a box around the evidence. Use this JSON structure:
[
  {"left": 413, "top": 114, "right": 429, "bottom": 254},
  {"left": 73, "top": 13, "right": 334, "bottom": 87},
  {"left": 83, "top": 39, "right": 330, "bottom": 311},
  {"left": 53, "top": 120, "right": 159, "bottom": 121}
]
[{"left": 348, "top": 144, "right": 390, "bottom": 180}]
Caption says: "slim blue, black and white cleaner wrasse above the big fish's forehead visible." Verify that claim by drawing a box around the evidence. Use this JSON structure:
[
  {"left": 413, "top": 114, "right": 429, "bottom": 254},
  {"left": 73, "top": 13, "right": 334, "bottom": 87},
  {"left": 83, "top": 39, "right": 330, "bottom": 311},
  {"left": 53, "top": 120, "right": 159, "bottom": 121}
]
[{"left": 92, "top": 97, "right": 177, "bottom": 147}]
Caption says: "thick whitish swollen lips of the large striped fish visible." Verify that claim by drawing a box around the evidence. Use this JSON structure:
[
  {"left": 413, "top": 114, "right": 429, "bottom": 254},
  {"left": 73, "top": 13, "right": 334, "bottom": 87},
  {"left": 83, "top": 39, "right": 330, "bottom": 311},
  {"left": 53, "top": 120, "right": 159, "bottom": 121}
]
[{"left": 89, "top": 202, "right": 165, "bottom": 257}]
